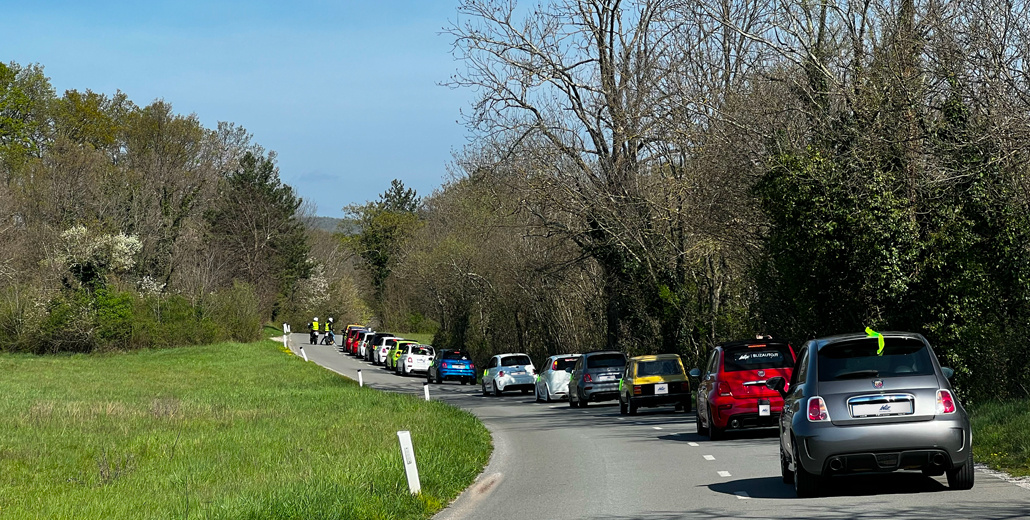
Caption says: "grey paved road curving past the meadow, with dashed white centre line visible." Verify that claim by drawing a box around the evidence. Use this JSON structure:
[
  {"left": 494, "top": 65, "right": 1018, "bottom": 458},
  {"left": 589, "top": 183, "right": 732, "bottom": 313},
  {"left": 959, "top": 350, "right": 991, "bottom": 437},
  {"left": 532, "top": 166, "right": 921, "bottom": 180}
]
[{"left": 294, "top": 335, "right": 1030, "bottom": 520}]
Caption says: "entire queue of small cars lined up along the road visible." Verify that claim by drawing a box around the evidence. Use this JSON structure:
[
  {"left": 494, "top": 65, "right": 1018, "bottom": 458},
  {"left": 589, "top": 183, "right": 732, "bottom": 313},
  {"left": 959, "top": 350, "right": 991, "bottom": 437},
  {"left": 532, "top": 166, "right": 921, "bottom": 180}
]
[{"left": 321, "top": 325, "right": 974, "bottom": 496}]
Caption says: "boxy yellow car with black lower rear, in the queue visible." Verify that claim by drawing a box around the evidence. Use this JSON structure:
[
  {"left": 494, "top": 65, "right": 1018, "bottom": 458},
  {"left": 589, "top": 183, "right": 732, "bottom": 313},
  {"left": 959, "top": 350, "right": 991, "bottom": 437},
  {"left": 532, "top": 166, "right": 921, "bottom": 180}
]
[{"left": 619, "top": 354, "right": 692, "bottom": 415}]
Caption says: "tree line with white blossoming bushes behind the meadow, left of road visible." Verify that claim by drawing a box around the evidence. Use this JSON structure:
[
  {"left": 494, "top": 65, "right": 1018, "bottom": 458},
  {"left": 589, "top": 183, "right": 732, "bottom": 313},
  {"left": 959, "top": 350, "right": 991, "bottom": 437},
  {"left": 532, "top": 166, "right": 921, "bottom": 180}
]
[{"left": 0, "top": 63, "right": 328, "bottom": 353}]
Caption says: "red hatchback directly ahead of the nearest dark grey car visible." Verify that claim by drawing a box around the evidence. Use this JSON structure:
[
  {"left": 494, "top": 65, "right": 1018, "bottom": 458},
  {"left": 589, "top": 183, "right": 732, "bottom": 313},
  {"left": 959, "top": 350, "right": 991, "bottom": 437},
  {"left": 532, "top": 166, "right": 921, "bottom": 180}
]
[{"left": 690, "top": 338, "right": 795, "bottom": 441}]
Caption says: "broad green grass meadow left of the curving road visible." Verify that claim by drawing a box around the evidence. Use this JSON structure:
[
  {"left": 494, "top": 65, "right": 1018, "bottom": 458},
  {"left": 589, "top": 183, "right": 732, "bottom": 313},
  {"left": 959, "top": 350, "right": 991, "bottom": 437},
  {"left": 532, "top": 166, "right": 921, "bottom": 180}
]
[{"left": 0, "top": 341, "right": 492, "bottom": 519}]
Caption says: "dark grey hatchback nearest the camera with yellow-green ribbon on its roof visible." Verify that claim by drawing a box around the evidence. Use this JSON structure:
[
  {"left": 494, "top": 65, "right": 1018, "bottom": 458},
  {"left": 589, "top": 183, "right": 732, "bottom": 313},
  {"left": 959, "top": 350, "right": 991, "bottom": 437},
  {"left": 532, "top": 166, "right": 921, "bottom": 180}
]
[{"left": 766, "top": 333, "right": 973, "bottom": 496}]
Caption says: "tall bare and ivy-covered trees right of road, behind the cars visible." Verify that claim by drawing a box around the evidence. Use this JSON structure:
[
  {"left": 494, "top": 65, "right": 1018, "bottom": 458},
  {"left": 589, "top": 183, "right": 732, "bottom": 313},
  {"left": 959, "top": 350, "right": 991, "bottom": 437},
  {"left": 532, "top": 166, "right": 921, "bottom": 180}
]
[{"left": 343, "top": 0, "right": 1030, "bottom": 398}]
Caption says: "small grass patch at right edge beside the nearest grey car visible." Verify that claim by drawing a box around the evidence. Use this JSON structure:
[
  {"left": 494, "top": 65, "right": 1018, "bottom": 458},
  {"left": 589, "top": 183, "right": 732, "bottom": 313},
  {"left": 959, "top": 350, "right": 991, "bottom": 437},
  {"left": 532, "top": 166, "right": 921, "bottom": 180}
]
[{"left": 970, "top": 400, "right": 1030, "bottom": 477}]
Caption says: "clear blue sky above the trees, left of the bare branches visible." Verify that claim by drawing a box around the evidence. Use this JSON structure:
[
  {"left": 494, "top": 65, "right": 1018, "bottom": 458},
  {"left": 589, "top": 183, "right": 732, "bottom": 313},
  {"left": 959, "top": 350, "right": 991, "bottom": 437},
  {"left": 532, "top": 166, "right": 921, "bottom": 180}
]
[{"left": 0, "top": 0, "right": 473, "bottom": 216}]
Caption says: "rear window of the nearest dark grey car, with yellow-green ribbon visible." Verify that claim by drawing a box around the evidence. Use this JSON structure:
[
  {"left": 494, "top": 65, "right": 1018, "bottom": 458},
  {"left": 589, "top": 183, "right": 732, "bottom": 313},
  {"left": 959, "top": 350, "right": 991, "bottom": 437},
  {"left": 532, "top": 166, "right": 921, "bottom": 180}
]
[{"left": 819, "top": 338, "right": 933, "bottom": 381}]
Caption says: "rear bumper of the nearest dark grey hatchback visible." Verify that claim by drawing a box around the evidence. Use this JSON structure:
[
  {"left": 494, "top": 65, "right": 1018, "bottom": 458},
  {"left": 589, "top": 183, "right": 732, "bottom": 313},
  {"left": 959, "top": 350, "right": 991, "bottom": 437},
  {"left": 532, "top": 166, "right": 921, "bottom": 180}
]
[{"left": 794, "top": 416, "right": 972, "bottom": 475}]
